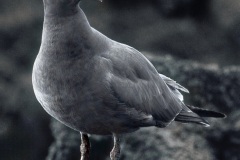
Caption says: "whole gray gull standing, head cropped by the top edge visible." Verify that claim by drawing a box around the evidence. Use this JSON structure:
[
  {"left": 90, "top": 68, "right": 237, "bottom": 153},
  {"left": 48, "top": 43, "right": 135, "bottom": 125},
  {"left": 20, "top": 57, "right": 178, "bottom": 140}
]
[{"left": 32, "top": 0, "right": 225, "bottom": 160}]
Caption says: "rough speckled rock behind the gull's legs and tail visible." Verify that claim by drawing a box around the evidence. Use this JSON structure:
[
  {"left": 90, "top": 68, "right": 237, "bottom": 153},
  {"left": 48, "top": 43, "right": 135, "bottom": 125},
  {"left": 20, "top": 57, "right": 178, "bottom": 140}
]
[{"left": 47, "top": 55, "right": 240, "bottom": 160}]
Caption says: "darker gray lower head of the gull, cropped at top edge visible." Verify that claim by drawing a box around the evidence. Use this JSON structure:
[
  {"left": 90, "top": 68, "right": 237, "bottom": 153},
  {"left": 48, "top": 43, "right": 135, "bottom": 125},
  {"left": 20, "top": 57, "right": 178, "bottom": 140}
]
[{"left": 43, "top": 0, "right": 80, "bottom": 16}]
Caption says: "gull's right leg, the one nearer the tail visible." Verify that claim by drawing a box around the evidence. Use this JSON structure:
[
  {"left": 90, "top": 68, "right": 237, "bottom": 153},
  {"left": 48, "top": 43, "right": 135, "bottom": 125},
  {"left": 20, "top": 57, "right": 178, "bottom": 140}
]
[{"left": 110, "top": 134, "right": 121, "bottom": 160}]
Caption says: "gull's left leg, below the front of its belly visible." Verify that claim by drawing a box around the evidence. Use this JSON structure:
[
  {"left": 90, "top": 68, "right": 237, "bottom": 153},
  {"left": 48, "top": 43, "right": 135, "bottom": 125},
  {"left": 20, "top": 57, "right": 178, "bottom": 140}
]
[{"left": 80, "top": 133, "right": 90, "bottom": 160}]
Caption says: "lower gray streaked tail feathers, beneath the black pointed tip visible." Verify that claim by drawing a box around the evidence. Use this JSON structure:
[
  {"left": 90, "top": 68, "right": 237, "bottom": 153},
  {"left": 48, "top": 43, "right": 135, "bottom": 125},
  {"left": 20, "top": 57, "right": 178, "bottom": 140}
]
[{"left": 174, "top": 109, "right": 210, "bottom": 127}]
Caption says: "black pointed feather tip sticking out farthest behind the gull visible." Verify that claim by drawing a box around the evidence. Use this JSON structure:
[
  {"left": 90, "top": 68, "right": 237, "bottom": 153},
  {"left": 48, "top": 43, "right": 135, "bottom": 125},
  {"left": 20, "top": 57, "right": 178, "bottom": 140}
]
[{"left": 187, "top": 105, "right": 226, "bottom": 118}]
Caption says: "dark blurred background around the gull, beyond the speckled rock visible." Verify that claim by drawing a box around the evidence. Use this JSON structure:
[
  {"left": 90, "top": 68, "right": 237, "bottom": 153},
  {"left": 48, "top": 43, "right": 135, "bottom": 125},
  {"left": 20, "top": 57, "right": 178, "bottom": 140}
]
[{"left": 0, "top": 0, "right": 240, "bottom": 160}]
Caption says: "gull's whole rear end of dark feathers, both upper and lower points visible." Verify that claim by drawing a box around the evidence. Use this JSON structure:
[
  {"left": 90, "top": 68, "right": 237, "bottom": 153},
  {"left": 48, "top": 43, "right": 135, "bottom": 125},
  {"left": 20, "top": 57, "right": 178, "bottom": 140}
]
[{"left": 175, "top": 105, "right": 226, "bottom": 127}]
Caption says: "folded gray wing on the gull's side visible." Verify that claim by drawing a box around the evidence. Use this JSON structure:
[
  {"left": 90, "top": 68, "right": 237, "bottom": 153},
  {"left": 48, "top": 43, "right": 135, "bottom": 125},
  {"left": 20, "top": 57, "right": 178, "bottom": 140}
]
[{"left": 105, "top": 45, "right": 182, "bottom": 124}]
